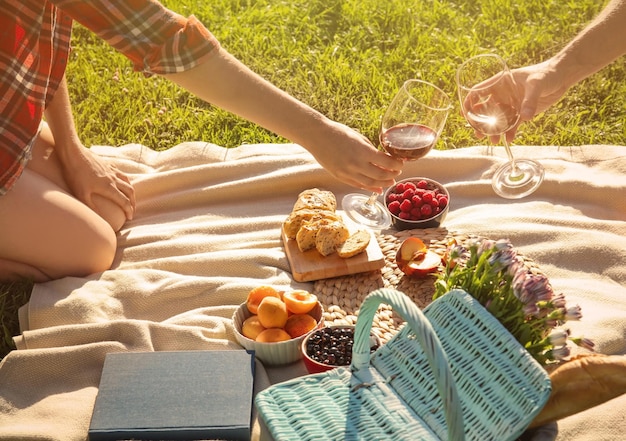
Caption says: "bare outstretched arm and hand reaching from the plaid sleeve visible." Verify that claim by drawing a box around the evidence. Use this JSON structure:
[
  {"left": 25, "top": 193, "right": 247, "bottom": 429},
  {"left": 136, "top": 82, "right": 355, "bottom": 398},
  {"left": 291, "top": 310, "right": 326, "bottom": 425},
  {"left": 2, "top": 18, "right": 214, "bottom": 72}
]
[{"left": 164, "top": 49, "right": 403, "bottom": 192}]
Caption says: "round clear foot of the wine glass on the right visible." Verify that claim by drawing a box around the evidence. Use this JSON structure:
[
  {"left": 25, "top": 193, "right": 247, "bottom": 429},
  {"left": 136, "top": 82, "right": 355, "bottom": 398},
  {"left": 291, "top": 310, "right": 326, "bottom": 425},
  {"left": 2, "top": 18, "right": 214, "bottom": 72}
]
[{"left": 491, "top": 159, "right": 545, "bottom": 199}]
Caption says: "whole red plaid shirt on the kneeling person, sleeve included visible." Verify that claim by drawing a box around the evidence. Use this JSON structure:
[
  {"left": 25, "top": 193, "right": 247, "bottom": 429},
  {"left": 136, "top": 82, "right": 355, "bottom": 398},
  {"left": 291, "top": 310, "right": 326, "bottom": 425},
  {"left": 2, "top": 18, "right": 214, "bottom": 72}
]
[{"left": 0, "top": 0, "right": 219, "bottom": 195}]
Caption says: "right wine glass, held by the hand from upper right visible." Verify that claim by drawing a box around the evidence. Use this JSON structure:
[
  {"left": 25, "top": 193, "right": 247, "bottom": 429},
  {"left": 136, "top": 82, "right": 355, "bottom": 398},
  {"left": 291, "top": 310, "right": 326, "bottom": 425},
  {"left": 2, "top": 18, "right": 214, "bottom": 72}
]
[{"left": 456, "top": 54, "right": 545, "bottom": 199}]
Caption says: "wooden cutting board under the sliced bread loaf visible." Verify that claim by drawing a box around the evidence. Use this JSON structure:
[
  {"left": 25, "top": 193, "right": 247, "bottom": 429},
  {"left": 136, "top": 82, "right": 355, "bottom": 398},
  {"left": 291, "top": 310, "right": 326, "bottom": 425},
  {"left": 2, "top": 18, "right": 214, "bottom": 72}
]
[{"left": 281, "top": 216, "right": 385, "bottom": 282}]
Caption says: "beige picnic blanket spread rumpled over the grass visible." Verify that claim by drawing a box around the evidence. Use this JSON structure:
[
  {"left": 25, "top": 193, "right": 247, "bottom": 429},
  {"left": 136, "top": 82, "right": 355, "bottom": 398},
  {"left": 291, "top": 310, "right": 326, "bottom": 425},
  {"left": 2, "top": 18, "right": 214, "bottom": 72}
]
[{"left": 0, "top": 142, "right": 626, "bottom": 441}]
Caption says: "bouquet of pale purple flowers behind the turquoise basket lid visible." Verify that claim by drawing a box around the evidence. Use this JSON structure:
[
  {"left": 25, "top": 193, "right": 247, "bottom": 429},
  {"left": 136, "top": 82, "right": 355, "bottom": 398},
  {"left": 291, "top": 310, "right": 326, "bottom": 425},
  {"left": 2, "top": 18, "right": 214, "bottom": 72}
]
[{"left": 434, "top": 239, "right": 594, "bottom": 366}]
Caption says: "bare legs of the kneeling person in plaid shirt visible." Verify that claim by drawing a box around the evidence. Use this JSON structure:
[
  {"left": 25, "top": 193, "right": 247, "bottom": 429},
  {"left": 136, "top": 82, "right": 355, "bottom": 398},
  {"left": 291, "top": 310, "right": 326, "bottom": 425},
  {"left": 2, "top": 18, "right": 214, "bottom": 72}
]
[{"left": 0, "top": 127, "right": 125, "bottom": 282}]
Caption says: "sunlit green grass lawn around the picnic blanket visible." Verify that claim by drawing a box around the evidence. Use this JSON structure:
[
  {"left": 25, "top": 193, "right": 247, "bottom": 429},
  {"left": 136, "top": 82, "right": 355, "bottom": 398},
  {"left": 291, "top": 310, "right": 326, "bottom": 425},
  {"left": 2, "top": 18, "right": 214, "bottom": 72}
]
[{"left": 0, "top": 0, "right": 626, "bottom": 357}]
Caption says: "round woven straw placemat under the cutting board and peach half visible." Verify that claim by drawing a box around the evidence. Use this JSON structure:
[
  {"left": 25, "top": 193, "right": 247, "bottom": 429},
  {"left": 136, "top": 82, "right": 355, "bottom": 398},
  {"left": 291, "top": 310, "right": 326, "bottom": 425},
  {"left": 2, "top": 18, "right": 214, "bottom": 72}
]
[{"left": 313, "top": 228, "right": 539, "bottom": 343}]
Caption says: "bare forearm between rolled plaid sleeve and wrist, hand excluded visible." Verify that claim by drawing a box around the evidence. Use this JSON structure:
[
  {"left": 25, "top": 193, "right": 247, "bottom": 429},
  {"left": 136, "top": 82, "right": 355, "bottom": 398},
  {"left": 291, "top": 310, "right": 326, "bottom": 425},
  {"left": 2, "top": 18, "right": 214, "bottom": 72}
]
[{"left": 165, "top": 49, "right": 330, "bottom": 151}]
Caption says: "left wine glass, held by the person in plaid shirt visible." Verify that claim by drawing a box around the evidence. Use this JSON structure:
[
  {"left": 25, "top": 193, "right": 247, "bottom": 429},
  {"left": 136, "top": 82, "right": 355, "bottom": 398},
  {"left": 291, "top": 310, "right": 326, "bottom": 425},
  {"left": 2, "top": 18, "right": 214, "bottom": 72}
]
[{"left": 341, "top": 80, "right": 452, "bottom": 229}]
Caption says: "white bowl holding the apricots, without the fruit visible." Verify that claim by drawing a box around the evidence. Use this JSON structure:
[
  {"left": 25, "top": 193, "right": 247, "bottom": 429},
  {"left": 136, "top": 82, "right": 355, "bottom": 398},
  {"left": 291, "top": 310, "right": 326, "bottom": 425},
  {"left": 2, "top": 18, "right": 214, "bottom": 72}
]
[{"left": 233, "top": 301, "right": 324, "bottom": 366}]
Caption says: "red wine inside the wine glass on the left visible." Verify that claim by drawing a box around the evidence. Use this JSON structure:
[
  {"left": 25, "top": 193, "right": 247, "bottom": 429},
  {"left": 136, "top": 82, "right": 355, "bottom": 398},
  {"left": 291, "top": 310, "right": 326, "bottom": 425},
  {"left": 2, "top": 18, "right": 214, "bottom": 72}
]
[{"left": 380, "top": 124, "right": 437, "bottom": 161}]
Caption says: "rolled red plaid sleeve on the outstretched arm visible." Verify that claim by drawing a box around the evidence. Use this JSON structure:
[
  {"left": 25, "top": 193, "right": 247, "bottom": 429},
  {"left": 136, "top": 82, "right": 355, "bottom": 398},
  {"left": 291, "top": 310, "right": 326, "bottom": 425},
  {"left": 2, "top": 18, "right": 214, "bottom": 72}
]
[{"left": 52, "top": 0, "right": 220, "bottom": 74}]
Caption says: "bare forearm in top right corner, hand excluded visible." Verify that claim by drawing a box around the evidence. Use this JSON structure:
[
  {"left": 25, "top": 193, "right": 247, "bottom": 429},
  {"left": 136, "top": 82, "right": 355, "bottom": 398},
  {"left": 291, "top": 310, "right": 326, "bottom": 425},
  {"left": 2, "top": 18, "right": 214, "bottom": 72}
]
[{"left": 550, "top": 0, "right": 626, "bottom": 88}]
